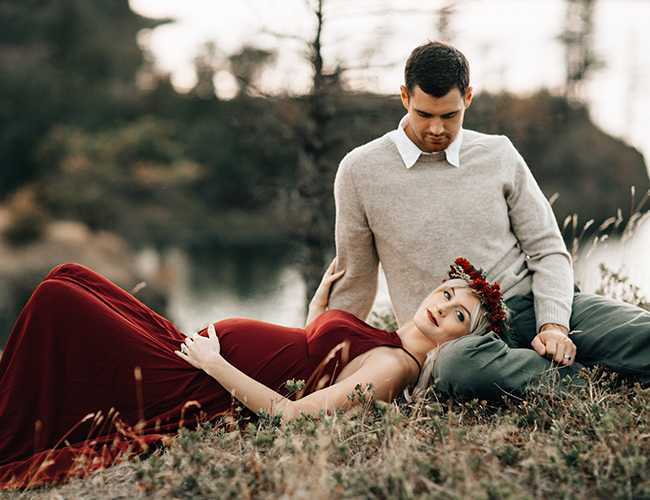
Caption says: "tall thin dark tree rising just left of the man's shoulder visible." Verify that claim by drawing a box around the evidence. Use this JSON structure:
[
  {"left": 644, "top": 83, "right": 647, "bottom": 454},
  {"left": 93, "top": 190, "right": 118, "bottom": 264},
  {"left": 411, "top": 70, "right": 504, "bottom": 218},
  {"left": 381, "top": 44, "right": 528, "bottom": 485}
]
[{"left": 260, "top": 0, "right": 401, "bottom": 299}]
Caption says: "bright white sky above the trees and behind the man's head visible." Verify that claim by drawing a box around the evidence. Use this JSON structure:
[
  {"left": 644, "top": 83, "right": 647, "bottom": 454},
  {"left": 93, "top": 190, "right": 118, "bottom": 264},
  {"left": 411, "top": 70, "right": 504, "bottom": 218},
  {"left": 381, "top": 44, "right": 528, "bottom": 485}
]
[{"left": 130, "top": 0, "right": 650, "bottom": 168}]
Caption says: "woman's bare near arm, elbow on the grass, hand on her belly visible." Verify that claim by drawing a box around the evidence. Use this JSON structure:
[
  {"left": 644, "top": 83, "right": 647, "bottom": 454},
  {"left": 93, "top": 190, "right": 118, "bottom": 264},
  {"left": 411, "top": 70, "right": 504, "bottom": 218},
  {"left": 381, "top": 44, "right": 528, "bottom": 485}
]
[{"left": 176, "top": 325, "right": 409, "bottom": 420}]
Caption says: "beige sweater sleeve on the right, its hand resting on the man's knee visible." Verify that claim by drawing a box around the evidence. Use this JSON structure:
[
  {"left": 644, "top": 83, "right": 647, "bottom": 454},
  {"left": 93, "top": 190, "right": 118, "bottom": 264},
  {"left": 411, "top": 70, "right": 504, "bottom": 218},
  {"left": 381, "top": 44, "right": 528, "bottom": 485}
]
[{"left": 501, "top": 139, "right": 573, "bottom": 332}]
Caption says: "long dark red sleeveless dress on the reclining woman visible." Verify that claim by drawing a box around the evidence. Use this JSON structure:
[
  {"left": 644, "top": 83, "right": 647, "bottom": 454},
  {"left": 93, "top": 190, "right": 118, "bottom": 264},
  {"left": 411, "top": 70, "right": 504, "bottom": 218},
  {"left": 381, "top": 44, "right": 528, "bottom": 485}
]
[{"left": 0, "top": 264, "right": 402, "bottom": 489}]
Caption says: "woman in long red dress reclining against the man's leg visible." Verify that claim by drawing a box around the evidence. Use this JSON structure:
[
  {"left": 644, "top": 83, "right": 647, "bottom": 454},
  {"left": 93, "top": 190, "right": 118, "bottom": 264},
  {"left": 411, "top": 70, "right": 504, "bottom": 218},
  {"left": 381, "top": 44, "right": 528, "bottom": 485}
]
[{"left": 0, "top": 259, "right": 504, "bottom": 488}]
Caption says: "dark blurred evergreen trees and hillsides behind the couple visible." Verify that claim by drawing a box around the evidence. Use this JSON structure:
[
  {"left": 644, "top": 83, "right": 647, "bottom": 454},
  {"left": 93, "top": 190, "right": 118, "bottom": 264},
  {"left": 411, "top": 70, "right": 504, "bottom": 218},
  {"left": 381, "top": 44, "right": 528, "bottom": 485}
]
[{"left": 0, "top": 0, "right": 650, "bottom": 254}]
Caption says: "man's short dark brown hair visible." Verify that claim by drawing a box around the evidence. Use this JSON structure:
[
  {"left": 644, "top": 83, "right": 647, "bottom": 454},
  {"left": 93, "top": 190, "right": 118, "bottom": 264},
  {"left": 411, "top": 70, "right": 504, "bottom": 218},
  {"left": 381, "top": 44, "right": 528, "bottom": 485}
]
[{"left": 404, "top": 41, "right": 469, "bottom": 97}]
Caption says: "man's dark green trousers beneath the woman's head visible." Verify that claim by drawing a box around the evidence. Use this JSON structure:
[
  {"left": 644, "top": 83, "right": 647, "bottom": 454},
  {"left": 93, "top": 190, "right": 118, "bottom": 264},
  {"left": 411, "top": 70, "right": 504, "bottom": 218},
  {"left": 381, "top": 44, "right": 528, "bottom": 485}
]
[{"left": 433, "top": 292, "right": 650, "bottom": 401}]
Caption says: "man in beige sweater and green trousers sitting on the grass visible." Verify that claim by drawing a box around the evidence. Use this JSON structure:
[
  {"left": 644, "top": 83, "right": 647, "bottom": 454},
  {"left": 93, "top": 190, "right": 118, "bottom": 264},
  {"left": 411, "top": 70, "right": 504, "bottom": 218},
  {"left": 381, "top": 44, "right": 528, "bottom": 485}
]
[{"left": 329, "top": 42, "right": 650, "bottom": 399}]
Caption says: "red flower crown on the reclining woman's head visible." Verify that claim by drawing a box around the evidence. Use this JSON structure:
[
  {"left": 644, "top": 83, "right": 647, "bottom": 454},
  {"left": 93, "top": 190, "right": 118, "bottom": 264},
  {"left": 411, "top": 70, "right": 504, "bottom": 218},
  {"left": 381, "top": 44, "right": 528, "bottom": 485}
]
[{"left": 449, "top": 258, "right": 508, "bottom": 336}]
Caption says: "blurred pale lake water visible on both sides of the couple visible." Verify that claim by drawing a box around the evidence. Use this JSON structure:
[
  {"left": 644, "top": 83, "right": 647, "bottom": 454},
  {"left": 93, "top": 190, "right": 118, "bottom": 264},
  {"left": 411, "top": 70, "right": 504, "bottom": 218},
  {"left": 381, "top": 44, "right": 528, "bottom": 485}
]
[{"left": 154, "top": 217, "right": 650, "bottom": 332}]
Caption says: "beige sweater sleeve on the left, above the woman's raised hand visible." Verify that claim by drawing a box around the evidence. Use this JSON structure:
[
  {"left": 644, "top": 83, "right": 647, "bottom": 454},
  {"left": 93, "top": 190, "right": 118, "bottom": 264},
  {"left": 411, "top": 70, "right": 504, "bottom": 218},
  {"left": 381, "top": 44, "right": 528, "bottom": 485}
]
[{"left": 329, "top": 158, "right": 379, "bottom": 319}]
